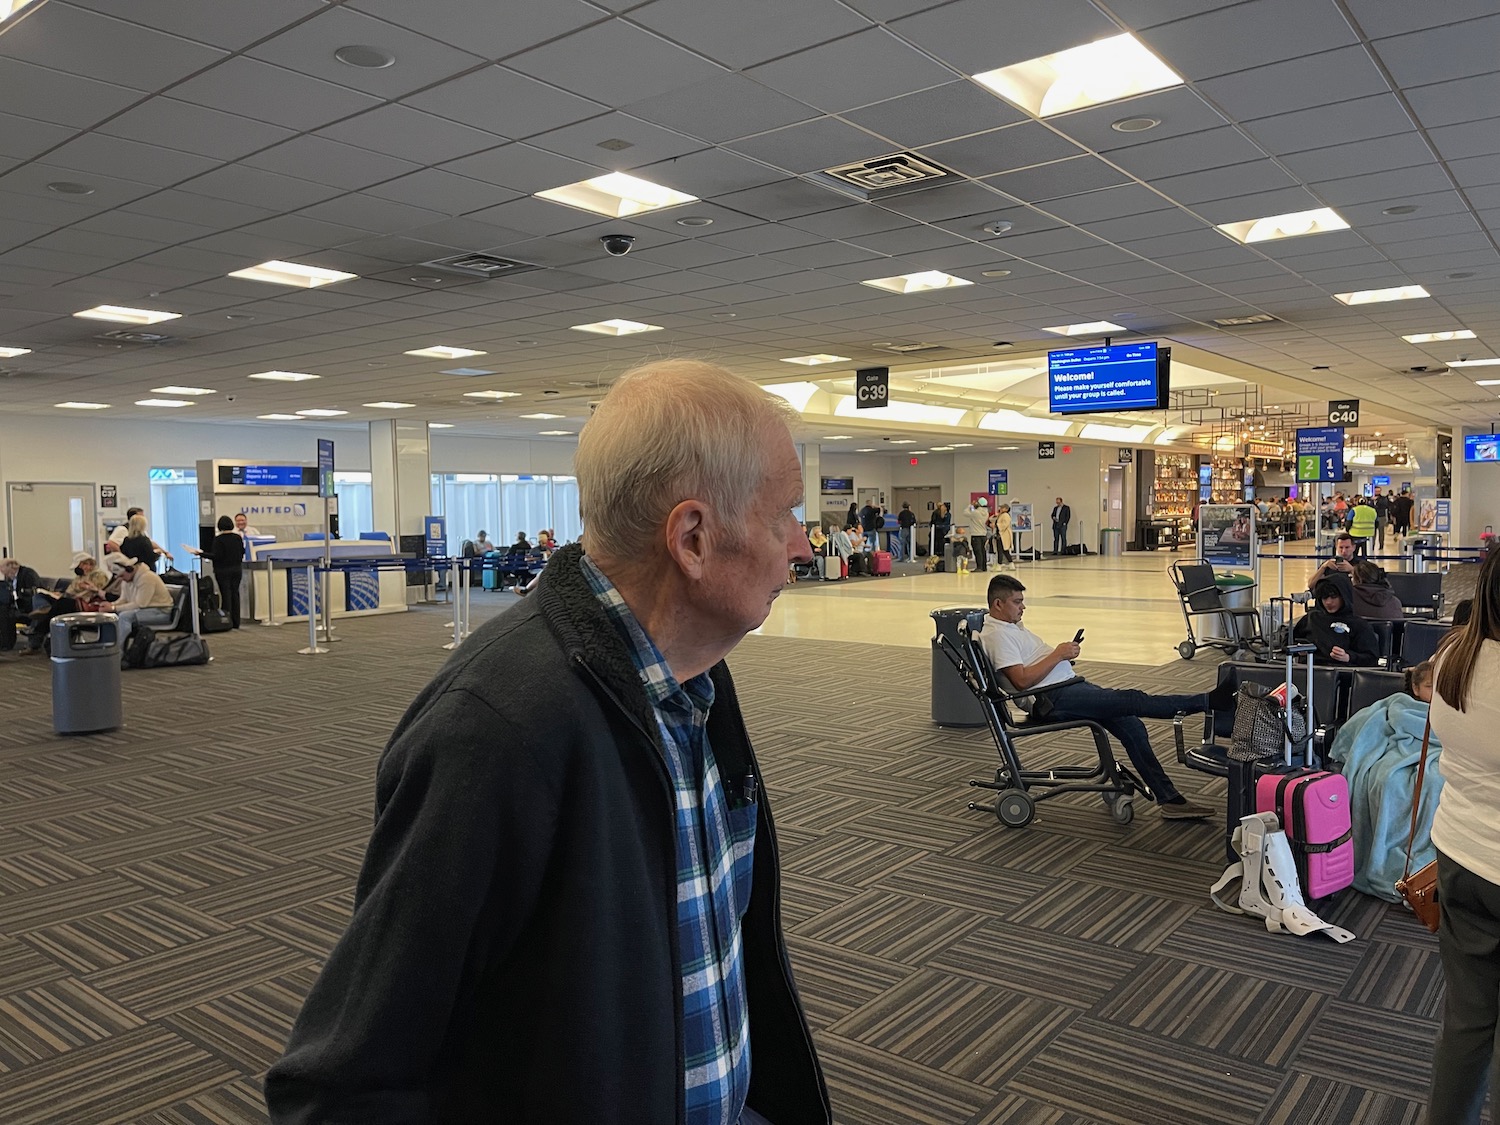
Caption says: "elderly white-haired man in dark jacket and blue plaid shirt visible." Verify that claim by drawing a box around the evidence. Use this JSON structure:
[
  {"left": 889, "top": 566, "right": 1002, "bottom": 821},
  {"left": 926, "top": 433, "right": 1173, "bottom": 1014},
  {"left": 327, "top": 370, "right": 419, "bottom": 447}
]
[{"left": 266, "top": 360, "right": 831, "bottom": 1125}]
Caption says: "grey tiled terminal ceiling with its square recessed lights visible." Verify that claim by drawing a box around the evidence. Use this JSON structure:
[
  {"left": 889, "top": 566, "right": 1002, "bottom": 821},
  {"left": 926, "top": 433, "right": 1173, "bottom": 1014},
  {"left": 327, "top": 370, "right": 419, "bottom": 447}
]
[{"left": 0, "top": 0, "right": 1500, "bottom": 453}]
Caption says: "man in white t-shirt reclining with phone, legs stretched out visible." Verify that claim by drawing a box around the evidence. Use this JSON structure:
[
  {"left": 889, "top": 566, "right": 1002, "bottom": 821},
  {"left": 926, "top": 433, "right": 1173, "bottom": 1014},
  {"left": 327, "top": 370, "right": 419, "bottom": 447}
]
[{"left": 980, "top": 575, "right": 1214, "bottom": 821}]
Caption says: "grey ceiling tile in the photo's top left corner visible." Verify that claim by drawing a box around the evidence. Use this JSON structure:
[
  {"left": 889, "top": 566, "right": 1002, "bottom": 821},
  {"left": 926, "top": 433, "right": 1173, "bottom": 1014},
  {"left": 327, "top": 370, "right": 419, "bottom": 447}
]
[{"left": 0, "top": 5, "right": 225, "bottom": 90}]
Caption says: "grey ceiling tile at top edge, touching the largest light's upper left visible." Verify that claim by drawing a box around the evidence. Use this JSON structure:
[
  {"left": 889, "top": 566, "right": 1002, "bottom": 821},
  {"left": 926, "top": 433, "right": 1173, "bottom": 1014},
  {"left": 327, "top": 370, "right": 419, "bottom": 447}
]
[{"left": 890, "top": 0, "right": 1119, "bottom": 75}]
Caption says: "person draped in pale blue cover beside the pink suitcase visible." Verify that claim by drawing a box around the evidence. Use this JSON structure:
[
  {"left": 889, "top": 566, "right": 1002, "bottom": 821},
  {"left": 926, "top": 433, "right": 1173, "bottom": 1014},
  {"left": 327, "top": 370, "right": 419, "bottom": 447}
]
[{"left": 1328, "top": 660, "right": 1443, "bottom": 903}]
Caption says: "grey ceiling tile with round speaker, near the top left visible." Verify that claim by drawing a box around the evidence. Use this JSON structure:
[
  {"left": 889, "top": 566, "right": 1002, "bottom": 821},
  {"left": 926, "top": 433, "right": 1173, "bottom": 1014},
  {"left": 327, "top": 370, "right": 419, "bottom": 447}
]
[{"left": 248, "top": 6, "right": 483, "bottom": 98}]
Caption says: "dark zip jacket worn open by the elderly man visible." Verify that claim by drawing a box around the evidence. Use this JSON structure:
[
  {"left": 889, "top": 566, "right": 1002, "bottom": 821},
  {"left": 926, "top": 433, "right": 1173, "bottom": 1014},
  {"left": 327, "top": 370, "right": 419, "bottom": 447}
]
[{"left": 266, "top": 546, "right": 831, "bottom": 1125}]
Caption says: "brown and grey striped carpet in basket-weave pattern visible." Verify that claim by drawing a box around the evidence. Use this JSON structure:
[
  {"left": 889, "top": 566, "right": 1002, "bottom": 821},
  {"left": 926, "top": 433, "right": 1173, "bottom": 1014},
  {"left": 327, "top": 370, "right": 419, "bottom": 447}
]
[{"left": 0, "top": 603, "right": 1442, "bottom": 1125}]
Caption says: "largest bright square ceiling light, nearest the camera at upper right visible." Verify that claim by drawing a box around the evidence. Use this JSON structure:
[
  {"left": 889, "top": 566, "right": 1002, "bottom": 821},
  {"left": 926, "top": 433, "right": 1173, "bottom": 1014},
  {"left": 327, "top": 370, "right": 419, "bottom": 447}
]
[{"left": 974, "top": 35, "right": 1182, "bottom": 117}]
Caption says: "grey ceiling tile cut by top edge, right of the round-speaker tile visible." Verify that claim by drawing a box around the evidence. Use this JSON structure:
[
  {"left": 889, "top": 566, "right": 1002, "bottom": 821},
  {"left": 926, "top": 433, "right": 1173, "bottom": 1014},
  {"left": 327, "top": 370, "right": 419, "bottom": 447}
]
[{"left": 350, "top": 0, "right": 602, "bottom": 59}]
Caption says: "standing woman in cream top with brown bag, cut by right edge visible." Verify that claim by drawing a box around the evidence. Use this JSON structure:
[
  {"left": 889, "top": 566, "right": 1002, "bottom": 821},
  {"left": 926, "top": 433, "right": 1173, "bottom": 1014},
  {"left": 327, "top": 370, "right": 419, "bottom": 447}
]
[{"left": 1428, "top": 554, "right": 1500, "bottom": 1125}]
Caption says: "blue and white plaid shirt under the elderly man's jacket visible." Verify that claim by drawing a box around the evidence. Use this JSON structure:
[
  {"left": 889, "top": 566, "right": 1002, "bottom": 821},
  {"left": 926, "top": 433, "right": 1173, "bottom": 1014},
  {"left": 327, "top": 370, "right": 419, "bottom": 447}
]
[{"left": 584, "top": 557, "right": 756, "bottom": 1125}]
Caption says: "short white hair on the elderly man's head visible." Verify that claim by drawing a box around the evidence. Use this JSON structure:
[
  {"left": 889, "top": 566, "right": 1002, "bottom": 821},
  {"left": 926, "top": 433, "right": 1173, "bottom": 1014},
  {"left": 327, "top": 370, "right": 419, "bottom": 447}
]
[{"left": 573, "top": 360, "right": 794, "bottom": 563}]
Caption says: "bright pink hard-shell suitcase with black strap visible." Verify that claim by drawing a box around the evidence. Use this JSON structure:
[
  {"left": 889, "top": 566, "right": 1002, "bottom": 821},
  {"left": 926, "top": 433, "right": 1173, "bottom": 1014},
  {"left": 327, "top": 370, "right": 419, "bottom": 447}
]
[{"left": 1256, "top": 770, "right": 1355, "bottom": 900}]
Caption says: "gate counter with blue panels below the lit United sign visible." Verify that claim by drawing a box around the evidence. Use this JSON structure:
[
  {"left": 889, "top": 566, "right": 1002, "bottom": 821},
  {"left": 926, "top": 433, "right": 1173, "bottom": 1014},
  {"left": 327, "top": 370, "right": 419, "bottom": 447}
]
[{"left": 246, "top": 539, "right": 408, "bottom": 621}]
